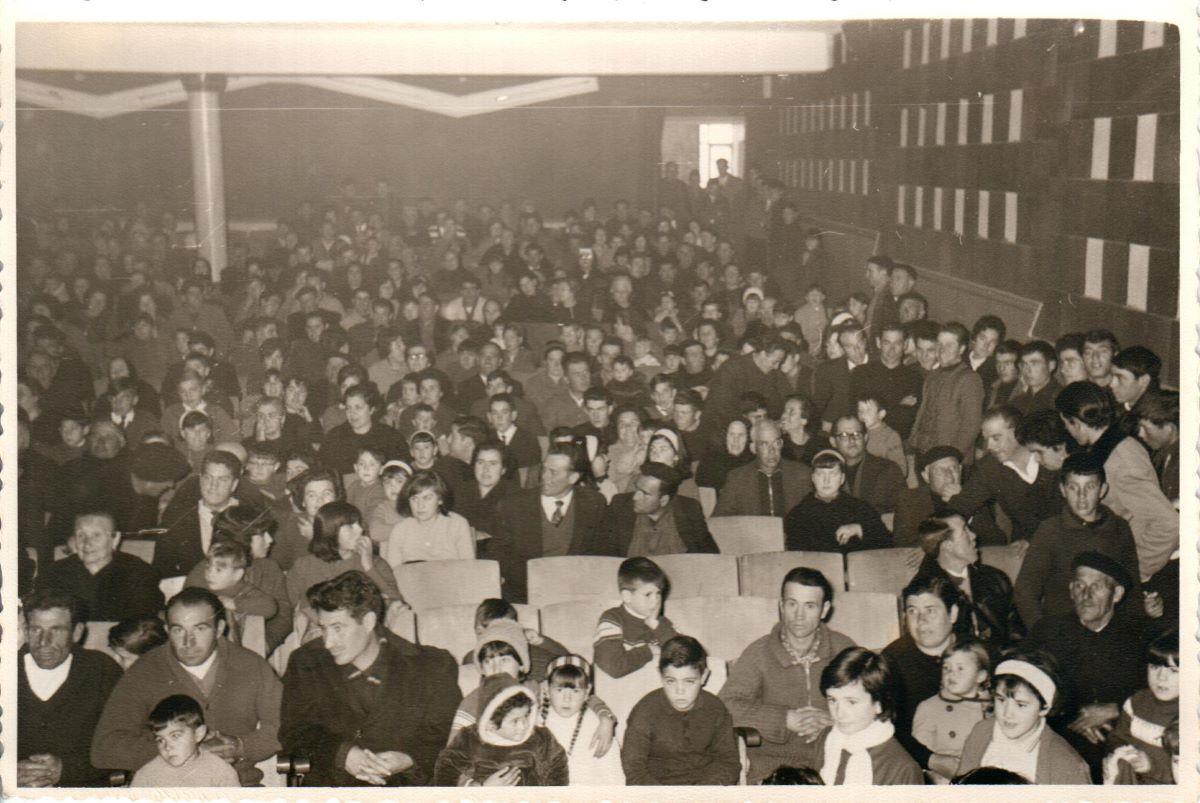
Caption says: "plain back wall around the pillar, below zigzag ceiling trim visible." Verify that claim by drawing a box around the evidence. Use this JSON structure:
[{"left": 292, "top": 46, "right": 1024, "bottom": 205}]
[{"left": 17, "top": 76, "right": 761, "bottom": 218}]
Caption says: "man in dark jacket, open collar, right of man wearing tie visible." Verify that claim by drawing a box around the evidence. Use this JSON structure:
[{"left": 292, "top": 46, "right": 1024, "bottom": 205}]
[{"left": 589, "top": 463, "right": 718, "bottom": 557}]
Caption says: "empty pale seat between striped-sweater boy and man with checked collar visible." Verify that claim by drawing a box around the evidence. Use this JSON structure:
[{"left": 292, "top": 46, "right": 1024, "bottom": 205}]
[{"left": 666, "top": 597, "right": 779, "bottom": 661}]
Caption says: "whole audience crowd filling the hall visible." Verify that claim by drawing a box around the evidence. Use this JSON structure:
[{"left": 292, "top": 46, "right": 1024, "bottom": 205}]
[{"left": 17, "top": 180, "right": 1180, "bottom": 786}]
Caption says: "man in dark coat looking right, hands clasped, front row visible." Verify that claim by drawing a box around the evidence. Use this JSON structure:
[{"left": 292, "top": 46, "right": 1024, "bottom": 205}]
[{"left": 280, "top": 571, "right": 462, "bottom": 786}]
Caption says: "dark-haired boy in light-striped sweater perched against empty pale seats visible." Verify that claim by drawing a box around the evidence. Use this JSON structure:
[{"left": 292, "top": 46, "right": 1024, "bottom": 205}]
[{"left": 594, "top": 557, "right": 676, "bottom": 676}]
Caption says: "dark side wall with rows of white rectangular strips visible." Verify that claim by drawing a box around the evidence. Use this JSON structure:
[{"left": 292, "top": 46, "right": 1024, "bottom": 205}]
[{"left": 748, "top": 19, "right": 1180, "bottom": 380}]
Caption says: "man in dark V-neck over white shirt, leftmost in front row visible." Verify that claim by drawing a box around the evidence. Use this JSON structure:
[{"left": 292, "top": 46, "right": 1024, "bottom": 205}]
[{"left": 19, "top": 589, "right": 121, "bottom": 787}]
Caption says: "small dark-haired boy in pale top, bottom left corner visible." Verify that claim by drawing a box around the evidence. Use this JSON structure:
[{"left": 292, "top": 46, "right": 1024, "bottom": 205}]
[{"left": 131, "top": 694, "right": 239, "bottom": 787}]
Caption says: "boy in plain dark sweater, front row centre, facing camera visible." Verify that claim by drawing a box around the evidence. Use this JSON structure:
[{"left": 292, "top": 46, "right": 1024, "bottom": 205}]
[{"left": 620, "top": 636, "right": 742, "bottom": 786}]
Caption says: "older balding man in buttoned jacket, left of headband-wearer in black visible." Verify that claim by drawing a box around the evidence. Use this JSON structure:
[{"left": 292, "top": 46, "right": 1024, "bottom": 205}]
[{"left": 713, "top": 419, "right": 812, "bottom": 519}]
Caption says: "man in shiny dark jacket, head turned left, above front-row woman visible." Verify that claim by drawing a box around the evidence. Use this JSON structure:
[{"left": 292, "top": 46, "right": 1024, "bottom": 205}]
[{"left": 917, "top": 513, "right": 1025, "bottom": 651}]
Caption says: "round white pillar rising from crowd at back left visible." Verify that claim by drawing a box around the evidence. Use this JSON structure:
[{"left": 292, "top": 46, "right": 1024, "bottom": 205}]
[{"left": 184, "top": 76, "right": 226, "bottom": 281}]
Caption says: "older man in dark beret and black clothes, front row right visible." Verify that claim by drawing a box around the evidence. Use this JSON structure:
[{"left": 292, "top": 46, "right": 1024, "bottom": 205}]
[{"left": 1027, "top": 551, "right": 1170, "bottom": 783}]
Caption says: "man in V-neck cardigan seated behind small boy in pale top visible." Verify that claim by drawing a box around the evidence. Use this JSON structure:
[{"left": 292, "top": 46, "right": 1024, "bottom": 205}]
[{"left": 91, "top": 588, "right": 283, "bottom": 786}]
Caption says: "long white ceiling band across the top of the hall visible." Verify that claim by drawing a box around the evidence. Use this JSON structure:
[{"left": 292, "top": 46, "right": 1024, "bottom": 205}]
[{"left": 16, "top": 22, "right": 840, "bottom": 76}]
